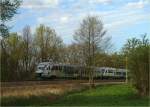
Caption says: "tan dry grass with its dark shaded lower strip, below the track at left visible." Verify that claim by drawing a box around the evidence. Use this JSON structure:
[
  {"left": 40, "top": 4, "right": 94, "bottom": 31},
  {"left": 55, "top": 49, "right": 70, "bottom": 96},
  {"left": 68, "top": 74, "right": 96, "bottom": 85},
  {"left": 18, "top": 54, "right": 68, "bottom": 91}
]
[{"left": 0, "top": 84, "right": 84, "bottom": 106}]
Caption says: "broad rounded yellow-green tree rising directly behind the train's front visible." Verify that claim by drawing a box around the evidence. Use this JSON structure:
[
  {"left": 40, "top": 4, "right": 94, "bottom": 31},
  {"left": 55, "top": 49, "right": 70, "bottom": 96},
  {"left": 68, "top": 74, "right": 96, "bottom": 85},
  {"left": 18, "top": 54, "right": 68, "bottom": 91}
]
[{"left": 34, "top": 25, "right": 63, "bottom": 61}]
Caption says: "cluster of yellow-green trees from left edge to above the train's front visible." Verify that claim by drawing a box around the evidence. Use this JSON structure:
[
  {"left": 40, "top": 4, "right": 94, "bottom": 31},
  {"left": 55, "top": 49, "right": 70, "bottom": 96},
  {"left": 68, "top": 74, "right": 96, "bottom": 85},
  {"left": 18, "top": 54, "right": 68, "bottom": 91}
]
[{"left": 1, "top": 25, "right": 63, "bottom": 81}]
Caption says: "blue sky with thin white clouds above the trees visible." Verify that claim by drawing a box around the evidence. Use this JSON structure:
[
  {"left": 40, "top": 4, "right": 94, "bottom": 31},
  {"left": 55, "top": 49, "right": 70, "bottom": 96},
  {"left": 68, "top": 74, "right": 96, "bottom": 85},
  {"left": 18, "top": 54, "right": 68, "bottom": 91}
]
[{"left": 9, "top": 0, "right": 150, "bottom": 50}]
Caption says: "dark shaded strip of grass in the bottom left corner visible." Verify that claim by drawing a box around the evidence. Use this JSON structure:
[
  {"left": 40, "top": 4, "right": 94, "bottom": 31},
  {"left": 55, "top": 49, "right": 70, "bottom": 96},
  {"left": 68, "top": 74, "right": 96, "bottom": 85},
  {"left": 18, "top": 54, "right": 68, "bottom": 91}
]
[{"left": 1, "top": 94, "right": 59, "bottom": 106}]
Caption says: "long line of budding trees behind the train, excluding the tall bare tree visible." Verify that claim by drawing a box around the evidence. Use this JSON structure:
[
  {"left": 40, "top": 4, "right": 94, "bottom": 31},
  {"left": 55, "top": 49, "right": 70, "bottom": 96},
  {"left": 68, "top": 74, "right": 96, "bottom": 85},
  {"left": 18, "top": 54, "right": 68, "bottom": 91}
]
[{"left": 1, "top": 21, "right": 125, "bottom": 81}]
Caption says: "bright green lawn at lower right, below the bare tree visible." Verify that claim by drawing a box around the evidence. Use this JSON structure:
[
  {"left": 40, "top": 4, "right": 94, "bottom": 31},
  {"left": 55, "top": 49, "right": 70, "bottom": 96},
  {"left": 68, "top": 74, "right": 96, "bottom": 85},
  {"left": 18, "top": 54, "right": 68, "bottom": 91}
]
[{"left": 51, "top": 85, "right": 148, "bottom": 106}]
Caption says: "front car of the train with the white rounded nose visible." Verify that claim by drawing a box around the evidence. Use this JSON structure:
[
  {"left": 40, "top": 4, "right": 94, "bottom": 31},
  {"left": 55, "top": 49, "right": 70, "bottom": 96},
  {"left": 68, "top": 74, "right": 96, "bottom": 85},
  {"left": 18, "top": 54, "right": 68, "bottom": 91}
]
[{"left": 35, "top": 62, "right": 81, "bottom": 78}]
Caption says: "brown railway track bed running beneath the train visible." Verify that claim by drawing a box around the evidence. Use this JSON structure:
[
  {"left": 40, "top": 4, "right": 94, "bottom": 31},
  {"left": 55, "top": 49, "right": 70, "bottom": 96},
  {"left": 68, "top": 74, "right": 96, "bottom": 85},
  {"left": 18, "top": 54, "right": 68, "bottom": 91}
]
[{"left": 0, "top": 79, "right": 124, "bottom": 87}]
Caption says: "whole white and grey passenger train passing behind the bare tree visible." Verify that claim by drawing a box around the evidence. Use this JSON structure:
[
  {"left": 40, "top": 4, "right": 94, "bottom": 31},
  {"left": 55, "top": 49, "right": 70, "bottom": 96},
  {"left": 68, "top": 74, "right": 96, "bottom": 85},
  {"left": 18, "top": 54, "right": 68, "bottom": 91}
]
[{"left": 35, "top": 62, "right": 128, "bottom": 79}]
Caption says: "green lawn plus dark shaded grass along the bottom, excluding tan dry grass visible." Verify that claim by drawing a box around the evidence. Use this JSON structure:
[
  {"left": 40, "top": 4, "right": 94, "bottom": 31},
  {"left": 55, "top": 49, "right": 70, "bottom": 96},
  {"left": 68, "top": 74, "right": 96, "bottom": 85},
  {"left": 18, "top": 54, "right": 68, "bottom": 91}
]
[{"left": 1, "top": 84, "right": 148, "bottom": 106}]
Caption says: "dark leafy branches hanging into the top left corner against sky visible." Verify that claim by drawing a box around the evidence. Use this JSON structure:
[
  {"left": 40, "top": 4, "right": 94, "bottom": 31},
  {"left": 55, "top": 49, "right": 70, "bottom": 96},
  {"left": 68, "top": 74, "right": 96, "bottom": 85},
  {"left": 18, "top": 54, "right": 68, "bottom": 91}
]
[{"left": 0, "top": 0, "right": 21, "bottom": 37}]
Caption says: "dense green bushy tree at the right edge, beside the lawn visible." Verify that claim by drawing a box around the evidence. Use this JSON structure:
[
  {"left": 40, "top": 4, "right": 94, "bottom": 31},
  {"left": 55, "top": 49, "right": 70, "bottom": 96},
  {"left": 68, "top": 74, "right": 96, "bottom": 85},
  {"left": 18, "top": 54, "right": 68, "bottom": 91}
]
[{"left": 123, "top": 34, "right": 150, "bottom": 96}]
